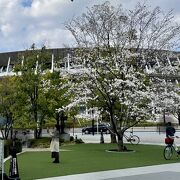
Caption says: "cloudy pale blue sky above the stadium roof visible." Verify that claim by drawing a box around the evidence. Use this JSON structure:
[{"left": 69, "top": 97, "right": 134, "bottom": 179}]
[{"left": 0, "top": 0, "right": 180, "bottom": 52}]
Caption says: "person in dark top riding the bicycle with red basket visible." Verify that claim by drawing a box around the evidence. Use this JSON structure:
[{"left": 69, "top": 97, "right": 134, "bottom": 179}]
[{"left": 166, "top": 122, "right": 180, "bottom": 154}]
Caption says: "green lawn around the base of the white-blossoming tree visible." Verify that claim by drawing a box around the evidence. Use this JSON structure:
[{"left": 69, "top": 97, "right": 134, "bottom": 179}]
[{"left": 5, "top": 144, "right": 180, "bottom": 180}]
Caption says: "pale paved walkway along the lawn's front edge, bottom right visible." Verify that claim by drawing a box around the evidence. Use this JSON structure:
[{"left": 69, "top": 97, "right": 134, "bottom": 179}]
[{"left": 36, "top": 163, "right": 180, "bottom": 180}]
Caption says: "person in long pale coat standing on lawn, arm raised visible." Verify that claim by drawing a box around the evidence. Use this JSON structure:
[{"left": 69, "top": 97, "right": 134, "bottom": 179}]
[{"left": 47, "top": 124, "right": 60, "bottom": 163}]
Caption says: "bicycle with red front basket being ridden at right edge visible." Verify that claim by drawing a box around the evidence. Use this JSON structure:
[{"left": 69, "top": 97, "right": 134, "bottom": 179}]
[{"left": 163, "top": 136, "right": 179, "bottom": 160}]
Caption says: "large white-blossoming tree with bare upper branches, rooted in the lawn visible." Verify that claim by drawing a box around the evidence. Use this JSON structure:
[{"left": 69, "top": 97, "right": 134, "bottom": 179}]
[{"left": 66, "top": 2, "right": 180, "bottom": 151}]
